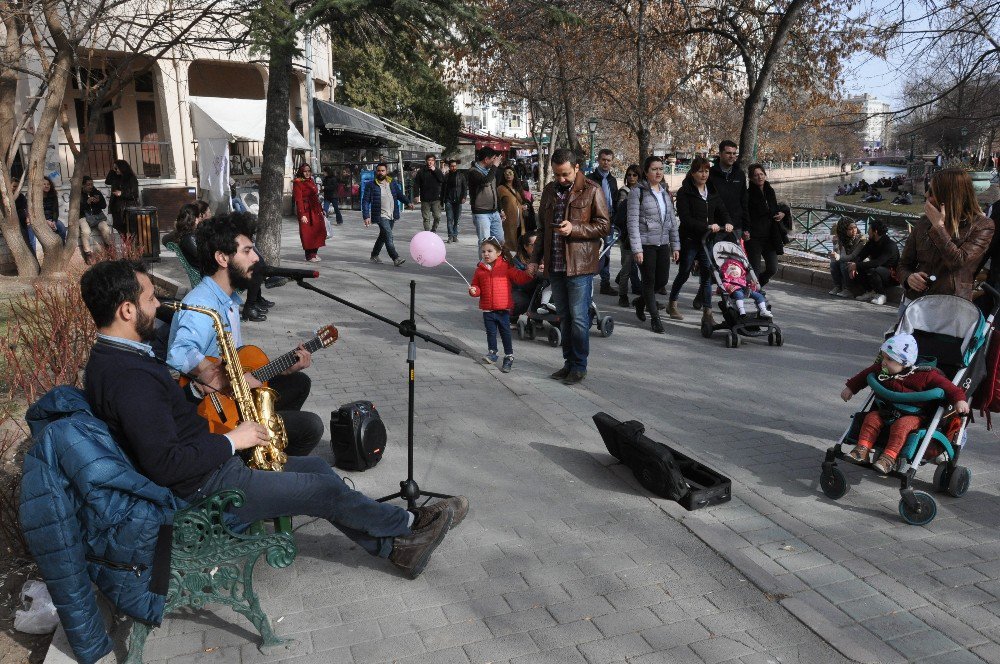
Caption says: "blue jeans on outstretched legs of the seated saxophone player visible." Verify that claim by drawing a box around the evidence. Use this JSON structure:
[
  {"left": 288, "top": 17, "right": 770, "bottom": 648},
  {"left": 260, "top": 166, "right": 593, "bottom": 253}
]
[{"left": 193, "top": 456, "right": 411, "bottom": 558}]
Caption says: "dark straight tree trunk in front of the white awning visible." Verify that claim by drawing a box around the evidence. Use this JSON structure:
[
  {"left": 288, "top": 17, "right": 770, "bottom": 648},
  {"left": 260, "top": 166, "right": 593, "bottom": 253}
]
[{"left": 256, "top": 43, "right": 292, "bottom": 265}]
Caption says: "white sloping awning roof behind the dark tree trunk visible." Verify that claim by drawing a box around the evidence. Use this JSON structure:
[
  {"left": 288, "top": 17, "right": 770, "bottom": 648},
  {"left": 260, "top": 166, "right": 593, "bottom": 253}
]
[{"left": 188, "top": 97, "right": 310, "bottom": 150}]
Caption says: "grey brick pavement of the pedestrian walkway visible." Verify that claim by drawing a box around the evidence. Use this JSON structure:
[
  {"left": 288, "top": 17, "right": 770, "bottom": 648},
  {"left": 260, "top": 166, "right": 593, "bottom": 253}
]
[{"left": 47, "top": 205, "right": 1000, "bottom": 664}]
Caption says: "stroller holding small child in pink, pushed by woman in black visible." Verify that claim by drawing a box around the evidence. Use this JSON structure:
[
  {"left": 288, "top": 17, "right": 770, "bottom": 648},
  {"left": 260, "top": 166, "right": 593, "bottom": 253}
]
[{"left": 701, "top": 232, "right": 785, "bottom": 348}]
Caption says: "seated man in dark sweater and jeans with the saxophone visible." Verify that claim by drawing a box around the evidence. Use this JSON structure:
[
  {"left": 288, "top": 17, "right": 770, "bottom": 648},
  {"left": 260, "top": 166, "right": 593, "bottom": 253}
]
[{"left": 80, "top": 256, "right": 469, "bottom": 578}]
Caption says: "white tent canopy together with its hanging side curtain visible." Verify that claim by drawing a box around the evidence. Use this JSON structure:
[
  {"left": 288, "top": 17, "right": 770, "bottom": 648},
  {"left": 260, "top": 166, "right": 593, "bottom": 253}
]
[{"left": 188, "top": 97, "right": 310, "bottom": 209}]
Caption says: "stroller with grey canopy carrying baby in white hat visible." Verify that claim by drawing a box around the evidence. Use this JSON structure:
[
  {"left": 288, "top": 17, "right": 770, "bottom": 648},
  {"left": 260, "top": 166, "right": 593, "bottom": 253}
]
[{"left": 820, "top": 295, "right": 1000, "bottom": 526}]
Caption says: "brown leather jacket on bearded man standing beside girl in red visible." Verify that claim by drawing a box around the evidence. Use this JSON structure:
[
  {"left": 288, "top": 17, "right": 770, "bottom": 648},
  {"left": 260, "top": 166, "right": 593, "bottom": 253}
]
[{"left": 531, "top": 171, "right": 611, "bottom": 277}]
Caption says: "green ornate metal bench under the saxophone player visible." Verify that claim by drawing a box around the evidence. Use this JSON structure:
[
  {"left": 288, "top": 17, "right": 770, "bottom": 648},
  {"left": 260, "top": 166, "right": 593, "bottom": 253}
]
[{"left": 125, "top": 489, "right": 298, "bottom": 664}]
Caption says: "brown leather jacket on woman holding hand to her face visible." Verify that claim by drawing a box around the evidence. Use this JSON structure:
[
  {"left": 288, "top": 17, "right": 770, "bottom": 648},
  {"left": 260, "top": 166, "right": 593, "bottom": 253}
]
[{"left": 896, "top": 215, "right": 993, "bottom": 300}]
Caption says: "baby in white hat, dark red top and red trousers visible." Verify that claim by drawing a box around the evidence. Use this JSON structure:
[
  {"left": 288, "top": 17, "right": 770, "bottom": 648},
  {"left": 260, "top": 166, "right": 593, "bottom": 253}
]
[{"left": 840, "top": 334, "right": 969, "bottom": 474}]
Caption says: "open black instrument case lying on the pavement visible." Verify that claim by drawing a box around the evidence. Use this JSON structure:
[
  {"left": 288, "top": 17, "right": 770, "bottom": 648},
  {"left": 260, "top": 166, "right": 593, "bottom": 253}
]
[{"left": 594, "top": 413, "right": 732, "bottom": 510}]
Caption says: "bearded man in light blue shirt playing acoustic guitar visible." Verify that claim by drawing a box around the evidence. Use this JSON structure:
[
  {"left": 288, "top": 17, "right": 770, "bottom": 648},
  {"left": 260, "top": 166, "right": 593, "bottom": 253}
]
[{"left": 167, "top": 212, "right": 323, "bottom": 456}]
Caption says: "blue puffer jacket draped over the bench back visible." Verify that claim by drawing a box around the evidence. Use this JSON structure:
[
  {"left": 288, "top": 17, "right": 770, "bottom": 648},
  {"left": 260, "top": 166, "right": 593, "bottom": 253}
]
[{"left": 20, "top": 387, "right": 183, "bottom": 664}]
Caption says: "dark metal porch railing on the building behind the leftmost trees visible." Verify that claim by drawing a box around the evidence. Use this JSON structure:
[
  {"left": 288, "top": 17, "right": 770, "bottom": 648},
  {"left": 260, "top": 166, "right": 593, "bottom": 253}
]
[{"left": 21, "top": 141, "right": 173, "bottom": 181}]
